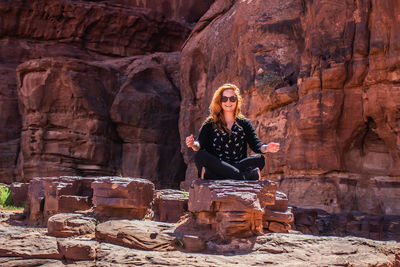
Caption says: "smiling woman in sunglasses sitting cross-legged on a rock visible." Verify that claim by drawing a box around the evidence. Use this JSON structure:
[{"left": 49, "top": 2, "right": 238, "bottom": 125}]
[{"left": 186, "top": 83, "right": 279, "bottom": 180}]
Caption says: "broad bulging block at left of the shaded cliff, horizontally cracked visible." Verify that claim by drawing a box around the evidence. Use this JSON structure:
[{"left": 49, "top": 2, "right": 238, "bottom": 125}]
[{"left": 17, "top": 58, "right": 121, "bottom": 181}]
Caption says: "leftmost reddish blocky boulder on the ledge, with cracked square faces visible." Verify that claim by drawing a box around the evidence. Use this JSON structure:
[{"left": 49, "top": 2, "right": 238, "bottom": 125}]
[{"left": 24, "top": 176, "right": 95, "bottom": 226}]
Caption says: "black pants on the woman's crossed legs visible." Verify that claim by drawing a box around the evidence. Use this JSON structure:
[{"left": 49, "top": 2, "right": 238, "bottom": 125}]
[{"left": 194, "top": 150, "right": 265, "bottom": 180}]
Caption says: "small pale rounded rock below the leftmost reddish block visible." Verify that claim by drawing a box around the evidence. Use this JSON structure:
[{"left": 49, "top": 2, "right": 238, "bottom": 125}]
[{"left": 47, "top": 213, "right": 95, "bottom": 237}]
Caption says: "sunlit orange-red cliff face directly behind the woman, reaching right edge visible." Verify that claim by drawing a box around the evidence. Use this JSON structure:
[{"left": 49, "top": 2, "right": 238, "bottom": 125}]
[{"left": 179, "top": 0, "right": 400, "bottom": 214}]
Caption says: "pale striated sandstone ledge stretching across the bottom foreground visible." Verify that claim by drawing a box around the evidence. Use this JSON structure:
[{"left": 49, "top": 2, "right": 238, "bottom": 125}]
[{"left": 0, "top": 221, "right": 400, "bottom": 267}]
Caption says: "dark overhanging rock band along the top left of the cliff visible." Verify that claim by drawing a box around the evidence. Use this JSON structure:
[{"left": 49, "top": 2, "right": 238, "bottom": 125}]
[{"left": 0, "top": 1, "right": 189, "bottom": 56}]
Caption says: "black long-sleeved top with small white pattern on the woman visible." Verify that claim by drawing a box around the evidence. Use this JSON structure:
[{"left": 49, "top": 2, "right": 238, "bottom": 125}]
[{"left": 198, "top": 119, "right": 263, "bottom": 163}]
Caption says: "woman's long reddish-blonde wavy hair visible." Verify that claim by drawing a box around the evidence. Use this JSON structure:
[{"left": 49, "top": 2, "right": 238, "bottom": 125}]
[{"left": 204, "top": 83, "right": 244, "bottom": 132}]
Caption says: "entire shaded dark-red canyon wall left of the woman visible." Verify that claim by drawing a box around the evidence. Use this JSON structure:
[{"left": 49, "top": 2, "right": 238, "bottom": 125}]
[{"left": 0, "top": 0, "right": 216, "bottom": 187}]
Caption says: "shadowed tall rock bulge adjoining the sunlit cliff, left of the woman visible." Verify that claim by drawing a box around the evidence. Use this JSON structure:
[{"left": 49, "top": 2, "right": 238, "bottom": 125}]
[{"left": 108, "top": 53, "right": 185, "bottom": 188}]
